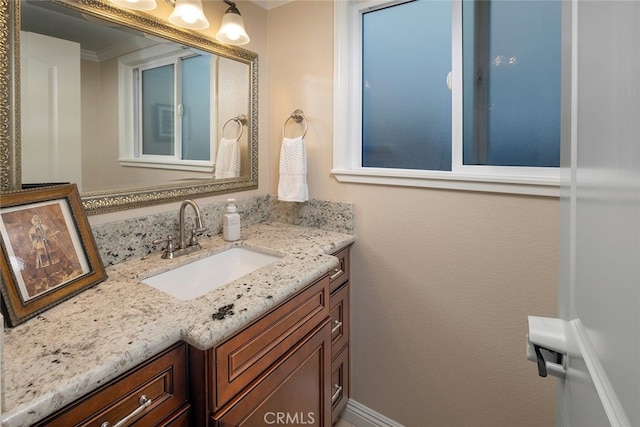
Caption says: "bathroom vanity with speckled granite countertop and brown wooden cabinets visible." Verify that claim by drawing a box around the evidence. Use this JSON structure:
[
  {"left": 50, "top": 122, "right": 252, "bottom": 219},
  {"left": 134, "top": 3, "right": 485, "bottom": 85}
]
[{"left": 2, "top": 224, "right": 353, "bottom": 427}]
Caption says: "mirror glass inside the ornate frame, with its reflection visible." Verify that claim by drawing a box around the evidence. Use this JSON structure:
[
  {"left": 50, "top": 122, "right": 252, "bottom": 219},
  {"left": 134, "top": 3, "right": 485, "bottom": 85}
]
[{"left": 20, "top": 0, "right": 250, "bottom": 192}]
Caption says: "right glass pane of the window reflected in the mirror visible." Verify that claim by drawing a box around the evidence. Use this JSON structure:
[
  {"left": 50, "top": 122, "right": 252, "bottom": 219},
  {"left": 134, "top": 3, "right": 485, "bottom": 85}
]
[{"left": 181, "top": 55, "right": 211, "bottom": 160}]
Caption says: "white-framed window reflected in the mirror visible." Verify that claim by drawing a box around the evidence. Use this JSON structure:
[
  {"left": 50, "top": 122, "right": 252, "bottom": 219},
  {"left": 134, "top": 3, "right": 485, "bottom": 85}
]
[{"left": 119, "top": 47, "right": 216, "bottom": 172}]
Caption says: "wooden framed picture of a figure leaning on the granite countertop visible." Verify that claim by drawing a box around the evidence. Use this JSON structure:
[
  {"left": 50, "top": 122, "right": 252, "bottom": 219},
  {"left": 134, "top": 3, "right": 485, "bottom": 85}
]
[{"left": 0, "top": 184, "right": 107, "bottom": 326}]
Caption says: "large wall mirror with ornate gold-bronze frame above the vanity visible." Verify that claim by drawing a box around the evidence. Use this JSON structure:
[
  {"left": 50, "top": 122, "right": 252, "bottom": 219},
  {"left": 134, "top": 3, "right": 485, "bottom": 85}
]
[{"left": 0, "top": 0, "right": 258, "bottom": 214}]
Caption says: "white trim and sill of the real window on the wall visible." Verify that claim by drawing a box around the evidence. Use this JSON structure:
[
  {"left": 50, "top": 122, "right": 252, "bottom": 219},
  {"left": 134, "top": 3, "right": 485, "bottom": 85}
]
[{"left": 331, "top": 0, "right": 560, "bottom": 197}]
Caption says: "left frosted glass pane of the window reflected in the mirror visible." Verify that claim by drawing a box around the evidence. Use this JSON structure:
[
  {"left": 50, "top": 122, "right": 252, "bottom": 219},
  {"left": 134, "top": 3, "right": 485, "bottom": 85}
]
[{"left": 142, "top": 64, "right": 175, "bottom": 156}]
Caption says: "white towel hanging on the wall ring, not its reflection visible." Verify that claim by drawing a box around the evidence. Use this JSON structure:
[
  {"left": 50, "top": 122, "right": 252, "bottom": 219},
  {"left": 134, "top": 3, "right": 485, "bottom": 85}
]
[{"left": 278, "top": 137, "right": 309, "bottom": 202}]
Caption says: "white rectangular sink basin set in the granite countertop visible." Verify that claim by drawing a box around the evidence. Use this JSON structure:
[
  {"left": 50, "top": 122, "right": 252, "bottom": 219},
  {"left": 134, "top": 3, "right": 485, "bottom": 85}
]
[{"left": 142, "top": 248, "right": 280, "bottom": 301}]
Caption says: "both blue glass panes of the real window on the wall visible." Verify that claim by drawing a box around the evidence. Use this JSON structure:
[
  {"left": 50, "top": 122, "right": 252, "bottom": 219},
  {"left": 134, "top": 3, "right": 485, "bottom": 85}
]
[{"left": 362, "top": 0, "right": 561, "bottom": 170}]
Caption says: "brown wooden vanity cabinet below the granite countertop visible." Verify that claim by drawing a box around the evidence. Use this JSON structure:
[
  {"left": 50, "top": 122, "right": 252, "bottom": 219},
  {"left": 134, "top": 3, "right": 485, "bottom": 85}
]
[{"left": 37, "top": 248, "right": 349, "bottom": 427}]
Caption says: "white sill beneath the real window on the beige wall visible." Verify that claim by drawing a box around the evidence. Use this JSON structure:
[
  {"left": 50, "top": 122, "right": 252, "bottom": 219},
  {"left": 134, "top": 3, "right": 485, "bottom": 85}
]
[{"left": 331, "top": 168, "right": 560, "bottom": 197}]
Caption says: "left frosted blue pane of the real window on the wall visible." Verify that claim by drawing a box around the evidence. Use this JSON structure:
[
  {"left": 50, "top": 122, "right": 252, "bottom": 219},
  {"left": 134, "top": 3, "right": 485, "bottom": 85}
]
[{"left": 362, "top": 1, "right": 452, "bottom": 170}]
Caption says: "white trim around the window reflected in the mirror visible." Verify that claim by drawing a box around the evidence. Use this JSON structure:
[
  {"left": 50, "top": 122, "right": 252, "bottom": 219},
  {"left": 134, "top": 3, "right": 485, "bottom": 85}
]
[{"left": 118, "top": 44, "right": 217, "bottom": 173}]
